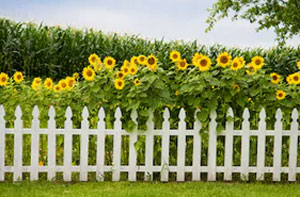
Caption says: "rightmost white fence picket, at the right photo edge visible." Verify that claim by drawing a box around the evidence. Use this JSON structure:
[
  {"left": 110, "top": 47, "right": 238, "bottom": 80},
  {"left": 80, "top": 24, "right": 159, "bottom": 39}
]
[{"left": 288, "top": 108, "right": 299, "bottom": 181}]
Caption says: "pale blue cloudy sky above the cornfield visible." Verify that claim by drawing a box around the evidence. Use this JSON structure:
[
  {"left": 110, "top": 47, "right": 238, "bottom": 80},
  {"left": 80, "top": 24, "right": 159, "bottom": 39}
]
[{"left": 0, "top": 0, "right": 300, "bottom": 48}]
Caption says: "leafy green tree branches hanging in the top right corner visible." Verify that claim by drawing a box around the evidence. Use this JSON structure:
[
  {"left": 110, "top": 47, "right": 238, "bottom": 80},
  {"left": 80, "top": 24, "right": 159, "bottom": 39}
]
[{"left": 206, "top": 0, "right": 300, "bottom": 44}]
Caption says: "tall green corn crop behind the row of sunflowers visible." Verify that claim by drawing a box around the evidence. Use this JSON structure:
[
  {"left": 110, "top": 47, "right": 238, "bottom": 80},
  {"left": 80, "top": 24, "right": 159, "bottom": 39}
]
[{"left": 0, "top": 18, "right": 300, "bottom": 79}]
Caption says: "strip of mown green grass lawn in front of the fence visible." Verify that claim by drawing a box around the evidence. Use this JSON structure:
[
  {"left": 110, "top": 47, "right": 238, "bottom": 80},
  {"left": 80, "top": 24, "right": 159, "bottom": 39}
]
[{"left": 0, "top": 181, "right": 300, "bottom": 197}]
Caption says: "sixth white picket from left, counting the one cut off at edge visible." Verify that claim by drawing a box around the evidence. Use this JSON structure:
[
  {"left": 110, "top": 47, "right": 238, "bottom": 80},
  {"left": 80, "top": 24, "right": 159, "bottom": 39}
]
[{"left": 80, "top": 107, "right": 89, "bottom": 181}]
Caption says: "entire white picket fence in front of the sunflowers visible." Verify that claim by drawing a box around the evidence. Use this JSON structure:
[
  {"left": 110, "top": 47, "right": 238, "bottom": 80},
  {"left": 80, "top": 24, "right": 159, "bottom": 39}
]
[{"left": 0, "top": 106, "right": 300, "bottom": 181}]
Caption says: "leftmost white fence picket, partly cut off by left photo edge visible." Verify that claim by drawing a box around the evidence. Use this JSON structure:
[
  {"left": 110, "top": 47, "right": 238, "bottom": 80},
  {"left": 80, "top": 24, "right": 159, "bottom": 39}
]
[{"left": 0, "top": 105, "right": 5, "bottom": 181}]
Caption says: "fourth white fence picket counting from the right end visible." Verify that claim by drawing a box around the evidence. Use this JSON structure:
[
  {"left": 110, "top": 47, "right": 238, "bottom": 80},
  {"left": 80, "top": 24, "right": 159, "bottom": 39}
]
[{"left": 241, "top": 108, "right": 250, "bottom": 181}]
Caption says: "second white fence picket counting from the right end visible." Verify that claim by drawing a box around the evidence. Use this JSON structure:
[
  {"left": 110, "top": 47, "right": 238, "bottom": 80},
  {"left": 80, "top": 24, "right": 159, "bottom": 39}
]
[{"left": 273, "top": 109, "right": 282, "bottom": 181}]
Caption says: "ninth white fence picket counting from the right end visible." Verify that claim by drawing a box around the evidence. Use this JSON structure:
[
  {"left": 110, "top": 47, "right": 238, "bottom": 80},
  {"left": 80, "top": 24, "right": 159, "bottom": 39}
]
[{"left": 160, "top": 108, "right": 170, "bottom": 182}]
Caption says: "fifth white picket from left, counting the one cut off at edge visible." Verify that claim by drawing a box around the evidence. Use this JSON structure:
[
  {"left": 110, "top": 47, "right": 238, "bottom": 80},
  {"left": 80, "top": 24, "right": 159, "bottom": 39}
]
[{"left": 63, "top": 107, "right": 73, "bottom": 182}]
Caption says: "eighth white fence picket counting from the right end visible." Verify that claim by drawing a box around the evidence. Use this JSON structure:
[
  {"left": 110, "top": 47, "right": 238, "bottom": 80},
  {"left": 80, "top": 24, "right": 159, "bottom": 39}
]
[{"left": 177, "top": 108, "right": 186, "bottom": 181}]
